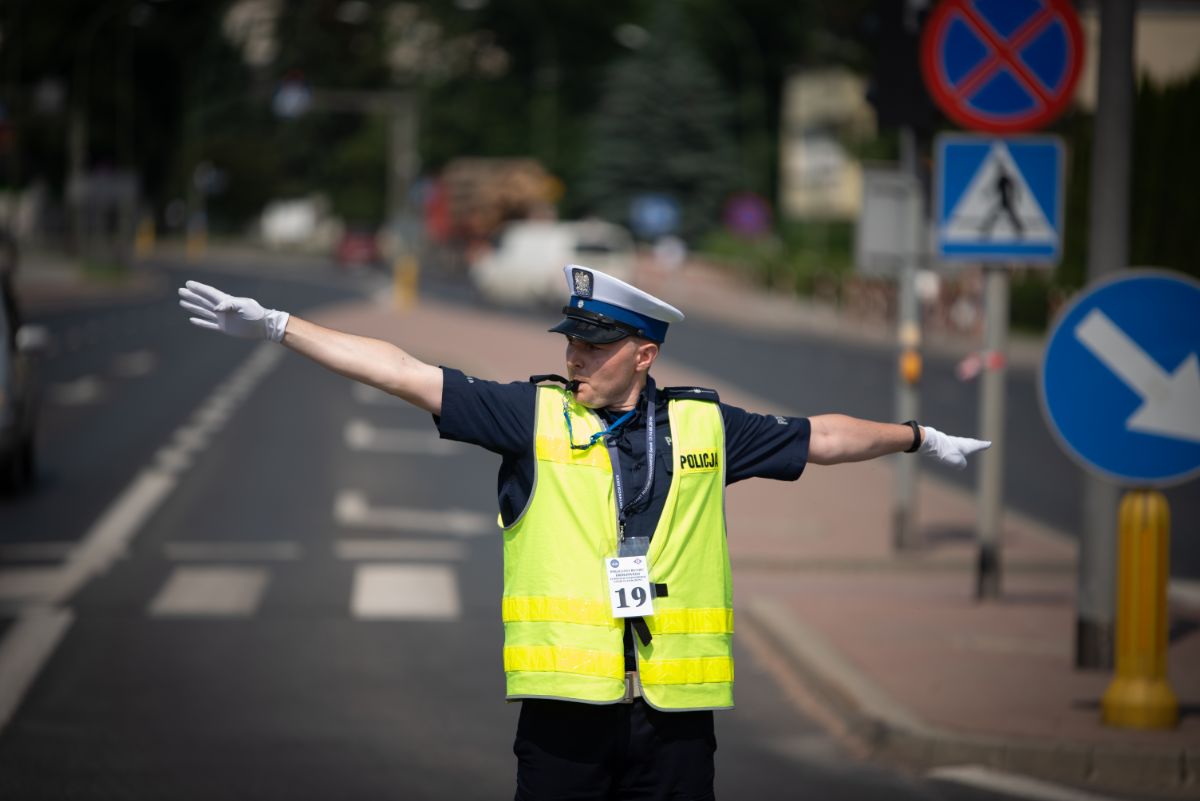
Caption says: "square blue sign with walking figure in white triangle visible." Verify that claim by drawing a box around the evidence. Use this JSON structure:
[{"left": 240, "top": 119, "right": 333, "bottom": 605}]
[{"left": 934, "top": 134, "right": 1064, "bottom": 265}]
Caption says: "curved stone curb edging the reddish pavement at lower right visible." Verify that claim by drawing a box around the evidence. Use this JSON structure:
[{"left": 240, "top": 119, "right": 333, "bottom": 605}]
[{"left": 748, "top": 598, "right": 1200, "bottom": 799}]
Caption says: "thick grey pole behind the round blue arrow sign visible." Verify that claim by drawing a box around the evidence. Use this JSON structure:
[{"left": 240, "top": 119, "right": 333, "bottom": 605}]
[{"left": 1075, "top": 0, "right": 1134, "bottom": 669}]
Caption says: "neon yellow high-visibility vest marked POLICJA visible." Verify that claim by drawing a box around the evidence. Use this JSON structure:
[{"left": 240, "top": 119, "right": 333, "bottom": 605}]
[{"left": 503, "top": 386, "right": 733, "bottom": 710}]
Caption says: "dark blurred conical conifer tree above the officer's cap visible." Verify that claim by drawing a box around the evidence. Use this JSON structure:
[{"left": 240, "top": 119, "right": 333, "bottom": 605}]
[{"left": 582, "top": 5, "right": 738, "bottom": 241}]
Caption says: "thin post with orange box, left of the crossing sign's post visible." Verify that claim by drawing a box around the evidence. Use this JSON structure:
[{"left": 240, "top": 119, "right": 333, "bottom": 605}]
[{"left": 892, "top": 126, "right": 924, "bottom": 550}]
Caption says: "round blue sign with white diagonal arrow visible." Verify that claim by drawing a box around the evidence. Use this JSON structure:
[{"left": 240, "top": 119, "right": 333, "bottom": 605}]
[{"left": 1039, "top": 270, "right": 1200, "bottom": 487}]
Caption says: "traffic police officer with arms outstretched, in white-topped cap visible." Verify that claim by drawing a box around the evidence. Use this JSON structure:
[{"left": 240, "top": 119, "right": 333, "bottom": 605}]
[{"left": 179, "top": 265, "right": 990, "bottom": 801}]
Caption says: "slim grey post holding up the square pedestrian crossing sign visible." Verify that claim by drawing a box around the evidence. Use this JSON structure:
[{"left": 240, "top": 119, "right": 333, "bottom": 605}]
[{"left": 976, "top": 264, "right": 1008, "bottom": 600}]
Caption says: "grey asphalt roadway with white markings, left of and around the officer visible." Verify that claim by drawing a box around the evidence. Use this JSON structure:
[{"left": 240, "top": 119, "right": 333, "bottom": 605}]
[{"left": 0, "top": 257, "right": 1161, "bottom": 801}]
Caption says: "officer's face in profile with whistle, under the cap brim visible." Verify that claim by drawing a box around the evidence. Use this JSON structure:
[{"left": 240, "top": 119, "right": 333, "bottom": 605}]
[{"left": 566, "top": 337, "right": 659, "bottom": 409}]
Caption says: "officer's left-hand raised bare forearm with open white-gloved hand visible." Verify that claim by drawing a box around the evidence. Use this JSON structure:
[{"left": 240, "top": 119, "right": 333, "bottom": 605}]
[{"left": 179, "top": 281, "right": 442, "bottom": 415}]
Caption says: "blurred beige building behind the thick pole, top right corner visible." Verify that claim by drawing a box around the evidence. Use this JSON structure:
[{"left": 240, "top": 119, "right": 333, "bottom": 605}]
[{"left": 1075, "top": 0, "right": 1200, "bottom": 112}]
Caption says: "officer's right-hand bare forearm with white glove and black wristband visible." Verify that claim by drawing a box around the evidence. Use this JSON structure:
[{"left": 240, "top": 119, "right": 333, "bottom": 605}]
[{"left": 809, "top": 415, "right": 991, "bottom": 468}]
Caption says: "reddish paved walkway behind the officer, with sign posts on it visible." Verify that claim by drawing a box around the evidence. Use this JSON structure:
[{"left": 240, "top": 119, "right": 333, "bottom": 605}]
[{"left": 304, "top": 270, "right": 1200, "bottom": 797}]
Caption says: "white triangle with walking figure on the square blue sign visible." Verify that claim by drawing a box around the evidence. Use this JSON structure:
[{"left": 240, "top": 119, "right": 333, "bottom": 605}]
[{"left": 942, "top": 141, "right": 1056, "bottom": 245}]
